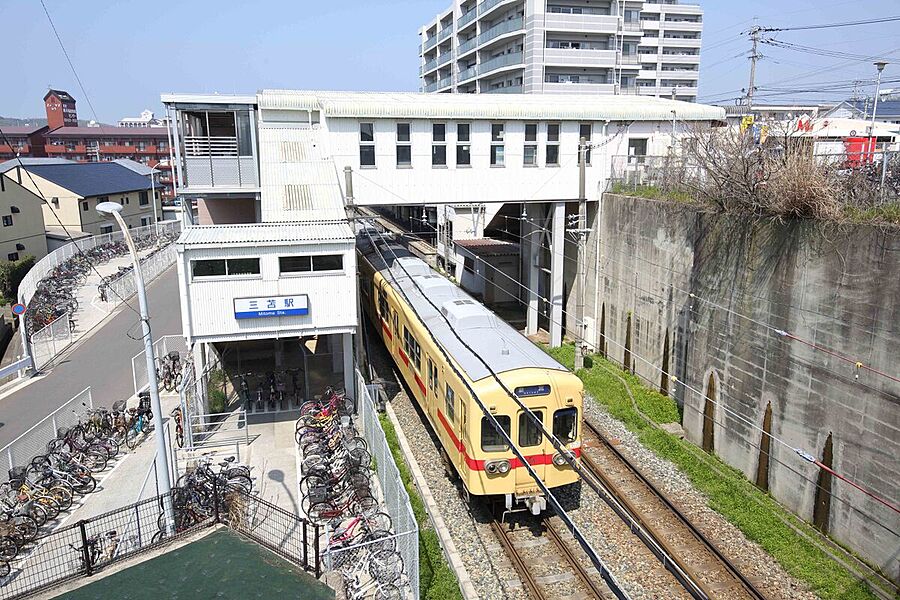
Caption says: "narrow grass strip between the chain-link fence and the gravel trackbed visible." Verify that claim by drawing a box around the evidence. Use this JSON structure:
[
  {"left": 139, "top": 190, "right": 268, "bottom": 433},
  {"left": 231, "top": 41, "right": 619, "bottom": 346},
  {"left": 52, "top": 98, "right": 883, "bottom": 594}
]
[{"left": 378, "top": 414, "right": 462, "bottom": 600}]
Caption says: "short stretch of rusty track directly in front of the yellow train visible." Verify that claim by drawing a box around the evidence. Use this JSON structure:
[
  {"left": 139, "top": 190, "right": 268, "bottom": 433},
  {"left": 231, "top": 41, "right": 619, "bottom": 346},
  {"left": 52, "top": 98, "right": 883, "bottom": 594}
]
[{"left": 491, "top": 510, "right": 612, "bottom": 600}]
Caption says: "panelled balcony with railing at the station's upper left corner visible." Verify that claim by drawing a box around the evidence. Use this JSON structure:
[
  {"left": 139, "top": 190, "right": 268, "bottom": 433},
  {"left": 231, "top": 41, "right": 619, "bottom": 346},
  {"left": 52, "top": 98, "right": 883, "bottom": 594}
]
[{"left": 184, "top": 136, "right": 259, "bottom": 189}]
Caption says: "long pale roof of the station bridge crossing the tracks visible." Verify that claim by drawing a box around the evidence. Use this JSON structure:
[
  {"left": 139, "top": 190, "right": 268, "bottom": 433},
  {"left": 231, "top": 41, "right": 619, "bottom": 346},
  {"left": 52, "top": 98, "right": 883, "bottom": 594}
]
[{"left": 258, "top": 90, "right": 725, "bottom": 121}]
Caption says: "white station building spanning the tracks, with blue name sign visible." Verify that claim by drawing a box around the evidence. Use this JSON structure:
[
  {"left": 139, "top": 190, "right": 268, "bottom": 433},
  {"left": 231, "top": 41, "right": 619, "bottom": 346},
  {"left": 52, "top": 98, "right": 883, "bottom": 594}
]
[{"left": 162, "top": 90, "right": 725, "bottom": 392}]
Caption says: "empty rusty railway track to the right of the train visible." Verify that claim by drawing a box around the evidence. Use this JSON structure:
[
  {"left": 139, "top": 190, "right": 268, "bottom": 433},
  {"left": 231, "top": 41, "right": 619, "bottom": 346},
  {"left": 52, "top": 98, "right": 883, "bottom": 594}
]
[{"left": 581, "top": 420, "right": 767, "bottom": 600}]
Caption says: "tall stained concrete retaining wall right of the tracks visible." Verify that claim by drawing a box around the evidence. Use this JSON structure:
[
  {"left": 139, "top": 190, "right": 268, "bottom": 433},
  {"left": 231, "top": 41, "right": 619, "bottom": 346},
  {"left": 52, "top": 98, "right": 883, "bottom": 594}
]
[{"left": 566, "top": 194, "right": 900, "bottom": 580}]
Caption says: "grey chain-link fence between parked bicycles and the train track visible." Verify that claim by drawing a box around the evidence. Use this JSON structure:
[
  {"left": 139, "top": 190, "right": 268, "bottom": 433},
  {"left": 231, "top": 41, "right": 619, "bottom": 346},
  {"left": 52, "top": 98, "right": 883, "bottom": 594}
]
[{"left": 324, "top": 371, "right": 419, "bottom": 599}]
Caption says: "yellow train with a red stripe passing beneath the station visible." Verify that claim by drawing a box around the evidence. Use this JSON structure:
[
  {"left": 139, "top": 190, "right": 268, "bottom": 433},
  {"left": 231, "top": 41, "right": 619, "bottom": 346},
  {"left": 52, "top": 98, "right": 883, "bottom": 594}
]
[{"left": 357, "top": 231, "right": 583, "bottom": 514}]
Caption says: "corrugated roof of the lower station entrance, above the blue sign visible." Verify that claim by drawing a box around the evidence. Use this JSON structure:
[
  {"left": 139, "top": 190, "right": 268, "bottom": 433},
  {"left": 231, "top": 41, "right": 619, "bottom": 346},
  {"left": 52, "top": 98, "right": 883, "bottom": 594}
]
[{"left": 178, "top": 220, "right": 355, "bottom": 246}]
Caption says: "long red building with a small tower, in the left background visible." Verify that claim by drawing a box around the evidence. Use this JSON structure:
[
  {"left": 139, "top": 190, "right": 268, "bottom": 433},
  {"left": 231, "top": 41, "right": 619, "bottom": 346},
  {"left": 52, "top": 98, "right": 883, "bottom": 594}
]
[{"left": 0, "top": 90, "right": 174, "bottom": 200}]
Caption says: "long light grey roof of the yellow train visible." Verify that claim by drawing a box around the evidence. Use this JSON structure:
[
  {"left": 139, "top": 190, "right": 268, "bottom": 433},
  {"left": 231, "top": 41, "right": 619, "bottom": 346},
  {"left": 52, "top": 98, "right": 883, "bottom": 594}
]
[{"left": 357, "top": 231, "right": 566, "bottom": 381}]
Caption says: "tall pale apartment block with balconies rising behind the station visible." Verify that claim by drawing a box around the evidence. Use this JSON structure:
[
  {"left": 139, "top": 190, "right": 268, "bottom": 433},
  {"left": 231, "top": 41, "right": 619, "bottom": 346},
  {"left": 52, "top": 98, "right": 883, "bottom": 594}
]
[{"left": 419, "top": 0, "right": 703, "bottom": 102}]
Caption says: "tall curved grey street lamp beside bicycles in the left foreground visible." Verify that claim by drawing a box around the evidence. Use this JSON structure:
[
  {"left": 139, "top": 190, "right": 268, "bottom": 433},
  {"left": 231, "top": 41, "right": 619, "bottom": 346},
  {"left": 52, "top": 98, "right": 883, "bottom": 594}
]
[{"left": 97, "top": 202, "right": 174, "bottom": 529}]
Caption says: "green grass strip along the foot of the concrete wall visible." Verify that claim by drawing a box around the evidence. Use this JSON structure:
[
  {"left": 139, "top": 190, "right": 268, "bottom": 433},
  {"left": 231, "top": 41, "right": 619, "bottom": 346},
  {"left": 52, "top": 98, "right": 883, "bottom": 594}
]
[{"left": 545, "top": 344, "right": 875, "bottom": 600}]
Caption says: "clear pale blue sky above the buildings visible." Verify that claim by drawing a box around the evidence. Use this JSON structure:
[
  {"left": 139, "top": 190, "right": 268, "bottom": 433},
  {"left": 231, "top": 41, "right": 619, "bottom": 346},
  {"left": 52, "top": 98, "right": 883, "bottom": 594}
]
[{"left": 0, "top": 0, "right": 900, "bottom": 123}]
